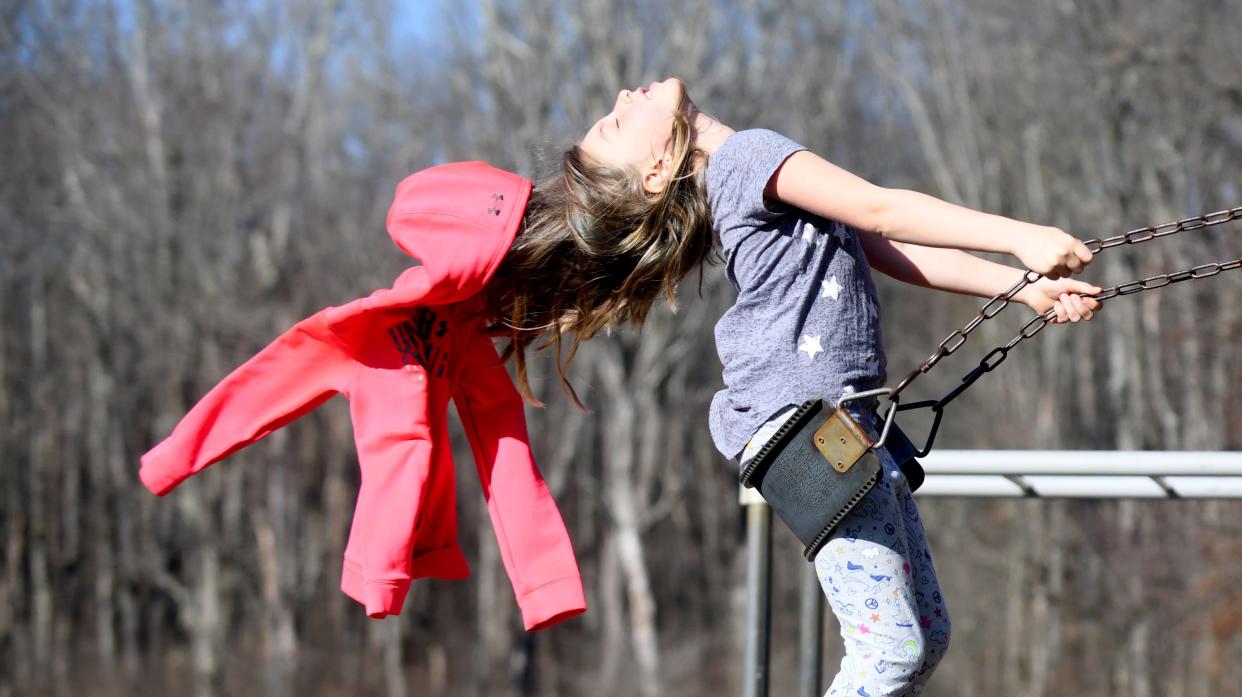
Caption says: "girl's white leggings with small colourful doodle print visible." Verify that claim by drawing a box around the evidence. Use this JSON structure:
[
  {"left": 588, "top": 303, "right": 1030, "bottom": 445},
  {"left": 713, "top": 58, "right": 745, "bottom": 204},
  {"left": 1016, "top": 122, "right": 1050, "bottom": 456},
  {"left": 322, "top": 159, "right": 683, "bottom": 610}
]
[{"left": 740, "top": 405, "right": 949, "bottom": 697}]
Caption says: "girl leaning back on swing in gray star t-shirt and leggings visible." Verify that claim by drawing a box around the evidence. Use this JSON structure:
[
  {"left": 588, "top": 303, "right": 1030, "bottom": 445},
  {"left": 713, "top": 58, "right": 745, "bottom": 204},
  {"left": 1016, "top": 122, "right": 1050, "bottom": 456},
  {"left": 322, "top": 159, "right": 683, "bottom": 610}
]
[{"left": 564, "top": 78, "right": 1100, "bottom": 696}]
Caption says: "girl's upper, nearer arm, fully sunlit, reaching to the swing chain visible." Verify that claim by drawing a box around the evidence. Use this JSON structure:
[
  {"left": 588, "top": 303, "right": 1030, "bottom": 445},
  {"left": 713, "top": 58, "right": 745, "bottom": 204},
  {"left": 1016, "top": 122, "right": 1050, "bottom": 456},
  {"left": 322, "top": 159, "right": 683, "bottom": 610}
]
[{"left": 766, "top": 150, "right": 1092, "bottom": 278}]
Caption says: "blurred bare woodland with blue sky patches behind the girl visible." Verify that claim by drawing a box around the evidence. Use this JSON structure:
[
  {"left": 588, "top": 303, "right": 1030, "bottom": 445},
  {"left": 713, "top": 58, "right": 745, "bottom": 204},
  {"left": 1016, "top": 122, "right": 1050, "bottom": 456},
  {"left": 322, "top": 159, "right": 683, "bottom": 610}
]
[{"left": 0, "top": 0, "right": 1242, "bottom": 697}]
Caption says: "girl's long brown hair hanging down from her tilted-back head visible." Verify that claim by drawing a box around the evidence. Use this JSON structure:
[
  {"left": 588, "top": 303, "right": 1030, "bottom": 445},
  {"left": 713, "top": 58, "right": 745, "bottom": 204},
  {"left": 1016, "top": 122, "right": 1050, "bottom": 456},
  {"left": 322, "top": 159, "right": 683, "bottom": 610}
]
[{"left": 487, "top": 86, "right": 713, "bottom": 410}]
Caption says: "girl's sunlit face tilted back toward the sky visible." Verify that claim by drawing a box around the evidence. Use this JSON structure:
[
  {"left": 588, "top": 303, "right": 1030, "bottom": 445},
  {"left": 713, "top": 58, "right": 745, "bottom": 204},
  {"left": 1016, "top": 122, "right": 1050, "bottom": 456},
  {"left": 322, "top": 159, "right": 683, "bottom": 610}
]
[{"left": 578, "top": 77, "right": 686, "bottom": 191}]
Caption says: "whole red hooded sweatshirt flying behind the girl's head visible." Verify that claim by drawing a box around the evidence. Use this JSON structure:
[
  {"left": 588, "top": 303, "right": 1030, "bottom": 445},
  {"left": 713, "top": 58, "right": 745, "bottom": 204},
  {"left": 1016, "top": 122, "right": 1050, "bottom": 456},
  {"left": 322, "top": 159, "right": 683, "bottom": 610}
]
[{"left": 139, "top": 162, "right": 586, "bottom": 630}]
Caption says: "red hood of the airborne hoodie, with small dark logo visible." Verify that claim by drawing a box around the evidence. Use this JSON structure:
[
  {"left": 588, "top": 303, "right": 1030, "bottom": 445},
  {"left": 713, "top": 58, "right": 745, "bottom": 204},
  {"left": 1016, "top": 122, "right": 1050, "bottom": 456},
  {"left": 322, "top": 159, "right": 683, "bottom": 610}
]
[{"left": 388, "top": 162, "right": 530, "bottom": 304}]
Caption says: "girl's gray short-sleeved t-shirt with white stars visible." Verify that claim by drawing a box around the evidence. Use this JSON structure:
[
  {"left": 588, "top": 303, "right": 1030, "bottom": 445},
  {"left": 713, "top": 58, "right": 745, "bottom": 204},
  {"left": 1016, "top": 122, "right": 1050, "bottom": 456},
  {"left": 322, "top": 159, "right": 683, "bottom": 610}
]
[{"left": 707, "top": 129, "right": 886, "bottom": 457}]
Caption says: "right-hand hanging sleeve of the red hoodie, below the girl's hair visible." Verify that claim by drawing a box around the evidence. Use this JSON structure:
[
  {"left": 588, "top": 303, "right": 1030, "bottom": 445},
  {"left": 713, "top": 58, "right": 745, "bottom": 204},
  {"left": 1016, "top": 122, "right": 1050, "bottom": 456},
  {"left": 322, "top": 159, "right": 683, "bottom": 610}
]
[{"left": 453, "top": 332, "right": 586, "bottom": 631}]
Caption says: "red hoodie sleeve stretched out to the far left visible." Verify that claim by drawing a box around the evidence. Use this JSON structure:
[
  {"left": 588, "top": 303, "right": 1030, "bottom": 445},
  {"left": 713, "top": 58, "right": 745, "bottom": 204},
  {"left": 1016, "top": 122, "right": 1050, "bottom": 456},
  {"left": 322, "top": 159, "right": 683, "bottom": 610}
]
[{"left": 138, "top": 311, "right": 353, "bottom": 496}]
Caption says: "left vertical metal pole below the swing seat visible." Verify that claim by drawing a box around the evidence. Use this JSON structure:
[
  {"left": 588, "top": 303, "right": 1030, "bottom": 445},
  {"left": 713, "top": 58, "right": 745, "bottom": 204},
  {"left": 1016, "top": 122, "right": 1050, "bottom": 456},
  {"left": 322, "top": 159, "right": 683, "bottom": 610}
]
[{"left": 739, "top": 487, "right": 773, "bottom": 697}]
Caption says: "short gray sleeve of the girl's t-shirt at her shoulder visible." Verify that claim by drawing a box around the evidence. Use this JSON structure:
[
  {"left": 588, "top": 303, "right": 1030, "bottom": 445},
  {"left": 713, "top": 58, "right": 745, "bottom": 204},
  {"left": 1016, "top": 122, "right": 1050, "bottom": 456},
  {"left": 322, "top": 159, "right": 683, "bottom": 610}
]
[{"left": 707, "top": 128, "right": 806, "bottom": 239}]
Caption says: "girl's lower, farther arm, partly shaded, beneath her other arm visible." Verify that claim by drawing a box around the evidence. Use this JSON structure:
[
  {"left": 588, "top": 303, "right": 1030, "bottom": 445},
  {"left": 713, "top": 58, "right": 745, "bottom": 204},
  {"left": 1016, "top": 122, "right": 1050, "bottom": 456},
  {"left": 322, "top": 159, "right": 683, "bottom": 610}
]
[{"left": 858, "top": 231, "right": 1100, "bottom": 323}]
